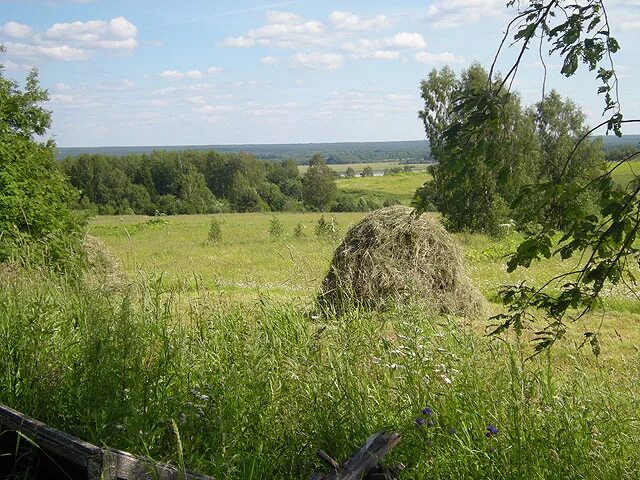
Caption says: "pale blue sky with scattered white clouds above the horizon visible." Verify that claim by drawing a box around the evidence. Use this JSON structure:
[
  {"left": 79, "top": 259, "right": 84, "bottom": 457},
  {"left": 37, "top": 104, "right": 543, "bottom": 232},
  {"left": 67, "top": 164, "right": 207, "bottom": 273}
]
[{"left": 0, "top": 0, "right": 640, "bottom": 146}]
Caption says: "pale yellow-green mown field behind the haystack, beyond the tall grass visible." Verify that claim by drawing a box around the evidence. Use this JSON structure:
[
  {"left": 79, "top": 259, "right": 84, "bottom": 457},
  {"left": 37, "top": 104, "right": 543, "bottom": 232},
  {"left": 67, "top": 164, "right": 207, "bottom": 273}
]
[{"left": 89, "top": 209, "right": 640, "bottom": 314}]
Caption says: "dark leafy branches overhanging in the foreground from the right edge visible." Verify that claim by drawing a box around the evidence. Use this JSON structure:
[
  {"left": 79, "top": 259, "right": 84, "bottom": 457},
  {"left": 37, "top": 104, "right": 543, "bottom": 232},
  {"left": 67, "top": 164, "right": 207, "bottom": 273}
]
[{"left": 444, "top": 1, "right": 640, "bottom": 353}]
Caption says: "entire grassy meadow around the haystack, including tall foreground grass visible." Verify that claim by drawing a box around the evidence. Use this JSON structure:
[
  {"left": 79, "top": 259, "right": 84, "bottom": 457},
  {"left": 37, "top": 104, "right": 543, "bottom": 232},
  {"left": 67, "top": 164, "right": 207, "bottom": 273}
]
[{"left": 0, "top": 174, "right": 640, "bottom": 480}]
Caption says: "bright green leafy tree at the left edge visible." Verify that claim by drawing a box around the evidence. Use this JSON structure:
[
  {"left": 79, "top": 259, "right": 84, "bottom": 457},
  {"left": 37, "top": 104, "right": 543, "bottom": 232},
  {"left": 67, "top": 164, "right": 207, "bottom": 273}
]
[{"left": 0, "top": 66, "right": 84, "bottom": 269}]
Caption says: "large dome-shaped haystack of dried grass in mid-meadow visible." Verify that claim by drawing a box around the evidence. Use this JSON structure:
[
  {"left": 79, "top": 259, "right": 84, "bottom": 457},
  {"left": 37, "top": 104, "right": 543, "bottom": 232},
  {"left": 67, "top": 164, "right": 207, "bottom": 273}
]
[{"left": 318, "top": 207, "right": 485, "bottom": 317}]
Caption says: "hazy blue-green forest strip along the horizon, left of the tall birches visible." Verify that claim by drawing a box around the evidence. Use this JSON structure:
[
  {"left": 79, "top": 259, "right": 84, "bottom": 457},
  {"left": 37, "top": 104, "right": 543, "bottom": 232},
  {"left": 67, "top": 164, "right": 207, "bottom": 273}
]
[{"left": 57, "top": 140, "right": 430, "bottom": 165}]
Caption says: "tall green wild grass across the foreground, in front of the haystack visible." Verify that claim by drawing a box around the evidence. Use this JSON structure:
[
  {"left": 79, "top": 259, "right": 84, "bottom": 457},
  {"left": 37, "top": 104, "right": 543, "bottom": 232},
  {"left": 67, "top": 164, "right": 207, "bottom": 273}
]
[{"left": 0, "top": 272, "right": 640, "bottom": 479}]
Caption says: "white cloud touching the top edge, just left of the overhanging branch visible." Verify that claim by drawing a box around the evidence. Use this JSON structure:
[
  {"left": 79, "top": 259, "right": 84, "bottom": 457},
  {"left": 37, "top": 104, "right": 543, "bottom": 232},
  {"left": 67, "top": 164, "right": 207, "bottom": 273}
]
[{"left": 427, "top": 0, "right": 506, "bottom": 28}]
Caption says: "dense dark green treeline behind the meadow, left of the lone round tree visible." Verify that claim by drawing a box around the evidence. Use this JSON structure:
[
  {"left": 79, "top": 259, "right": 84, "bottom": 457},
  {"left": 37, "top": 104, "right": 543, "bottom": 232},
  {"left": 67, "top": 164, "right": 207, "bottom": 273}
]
[{"left": 60, "top": 151, "right": 303, "bottom": 215}]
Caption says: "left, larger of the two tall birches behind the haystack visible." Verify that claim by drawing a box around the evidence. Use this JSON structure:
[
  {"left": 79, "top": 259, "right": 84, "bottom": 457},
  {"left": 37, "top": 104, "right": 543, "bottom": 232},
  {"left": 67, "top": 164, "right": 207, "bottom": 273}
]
[{"left": 416, "top": 64, "right": 541, "bottom": 235}]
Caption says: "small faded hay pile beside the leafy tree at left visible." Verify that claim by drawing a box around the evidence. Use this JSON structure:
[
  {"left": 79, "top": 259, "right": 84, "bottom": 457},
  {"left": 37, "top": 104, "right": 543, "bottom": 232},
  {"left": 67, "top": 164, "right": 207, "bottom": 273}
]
[{"left": 83, "top": 235, "right": 127, "bottom": 290}]
